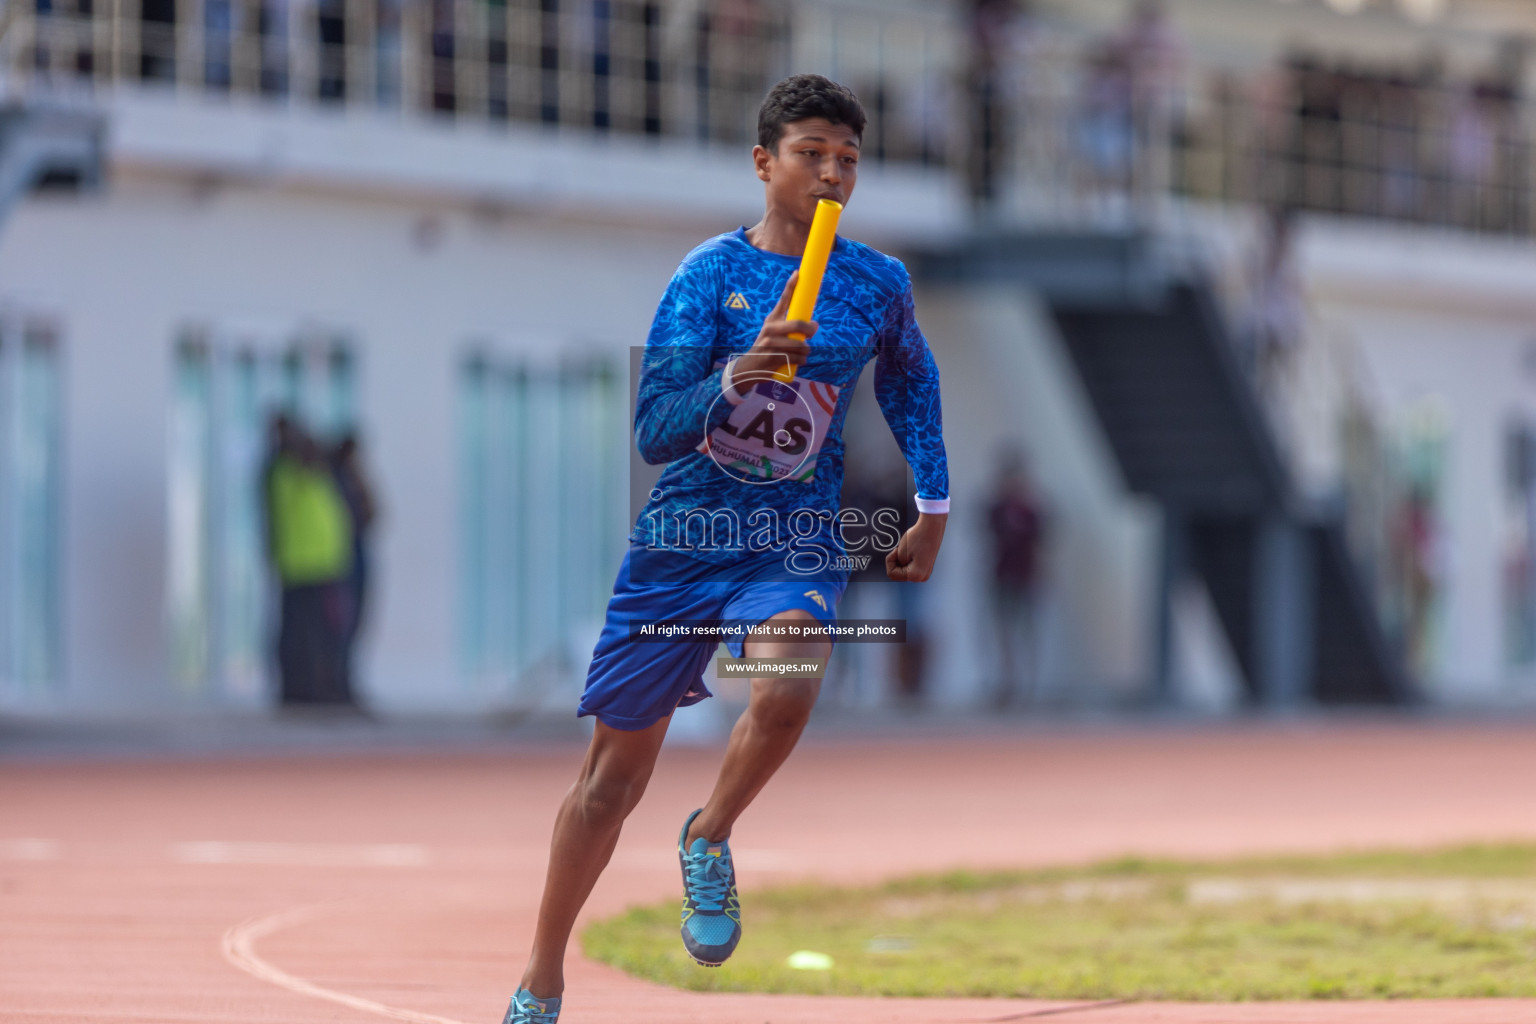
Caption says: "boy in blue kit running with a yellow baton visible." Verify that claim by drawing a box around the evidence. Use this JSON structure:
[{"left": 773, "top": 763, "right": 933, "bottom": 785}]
[{"left": 504, "top": 75, "right": 949, "bottom": 1024}]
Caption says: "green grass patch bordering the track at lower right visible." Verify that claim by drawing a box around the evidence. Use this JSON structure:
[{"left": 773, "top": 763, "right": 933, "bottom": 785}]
[{"left": 582, "top": 844, "right": 1536, "bottom": 1001}]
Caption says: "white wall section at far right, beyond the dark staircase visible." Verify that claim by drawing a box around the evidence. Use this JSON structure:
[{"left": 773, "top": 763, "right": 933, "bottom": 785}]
[{"left": 1299, "top": 220, "right": 1536, "bottom": 702}]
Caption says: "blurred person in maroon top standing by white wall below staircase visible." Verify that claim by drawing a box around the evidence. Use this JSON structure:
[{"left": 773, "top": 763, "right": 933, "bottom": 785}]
[{"left": 986, "top": 451, "right": 1046, "bottom": 708}]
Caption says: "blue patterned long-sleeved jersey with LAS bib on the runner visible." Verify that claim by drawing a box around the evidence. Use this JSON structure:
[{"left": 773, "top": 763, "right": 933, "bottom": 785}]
[{"left": 630, "top": 229, "right": 949, "bottom": 573}]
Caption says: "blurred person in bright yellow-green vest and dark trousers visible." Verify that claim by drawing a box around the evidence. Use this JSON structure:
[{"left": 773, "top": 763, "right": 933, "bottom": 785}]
[{"left": 263, "top": 415, "right": 355, "bottom": 706}]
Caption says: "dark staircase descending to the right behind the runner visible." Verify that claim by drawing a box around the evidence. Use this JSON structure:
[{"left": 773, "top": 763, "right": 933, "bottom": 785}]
[{"left": 914, "top": 235, "right": 1412, "bottom": 708}]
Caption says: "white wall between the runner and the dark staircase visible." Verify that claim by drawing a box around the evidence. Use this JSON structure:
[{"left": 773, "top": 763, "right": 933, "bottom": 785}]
[{"left": 917, "top": 286, "right": 1157, "bottom": 703}]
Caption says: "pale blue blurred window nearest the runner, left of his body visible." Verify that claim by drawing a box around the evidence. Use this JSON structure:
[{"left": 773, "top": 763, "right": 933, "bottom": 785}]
[{"left": 458, "top": 350, "right": 628, "bottom": 689}]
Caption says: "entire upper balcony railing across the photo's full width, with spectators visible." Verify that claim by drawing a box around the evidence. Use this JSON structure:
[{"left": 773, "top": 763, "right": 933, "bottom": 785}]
[{"left": 0, "top": 0, "right": 1536, "bottom": 235}]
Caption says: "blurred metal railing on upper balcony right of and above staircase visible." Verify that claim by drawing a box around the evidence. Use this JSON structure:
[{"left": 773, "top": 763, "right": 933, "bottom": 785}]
[{"left": 1014, "top": 55, "right": 1536, "bottom": 235}]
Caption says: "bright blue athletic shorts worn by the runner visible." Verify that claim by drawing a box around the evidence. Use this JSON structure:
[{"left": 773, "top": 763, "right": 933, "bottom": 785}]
[{"left": 576, "top": 545, "right": 848, "bottom": 731}]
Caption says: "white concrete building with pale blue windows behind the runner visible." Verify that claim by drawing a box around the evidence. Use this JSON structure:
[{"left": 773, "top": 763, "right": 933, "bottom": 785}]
[{"left": 0, "top": 0, "right": 1536, "bottom": 714}]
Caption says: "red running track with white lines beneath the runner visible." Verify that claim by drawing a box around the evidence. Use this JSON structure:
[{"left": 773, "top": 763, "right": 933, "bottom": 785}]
[{"left": 9, "top": 722, "right": 1536, "bottom": 1024}]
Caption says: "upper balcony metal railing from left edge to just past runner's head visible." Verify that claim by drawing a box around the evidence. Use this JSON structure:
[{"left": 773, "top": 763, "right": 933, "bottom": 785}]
[{"left": 0, "top": 0, "right": 952, "bottom": 155}]
